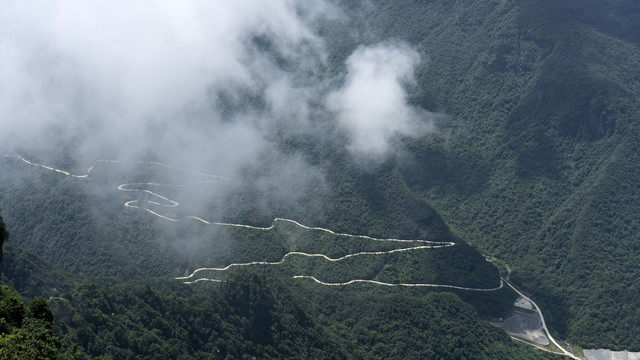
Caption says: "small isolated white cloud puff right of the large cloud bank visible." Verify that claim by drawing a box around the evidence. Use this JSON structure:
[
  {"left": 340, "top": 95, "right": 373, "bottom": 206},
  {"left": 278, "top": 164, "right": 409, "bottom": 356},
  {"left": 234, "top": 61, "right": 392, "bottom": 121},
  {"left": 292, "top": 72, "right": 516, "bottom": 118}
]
[{"left": 327, "top": 43, "right": 433, "bottom": 160}]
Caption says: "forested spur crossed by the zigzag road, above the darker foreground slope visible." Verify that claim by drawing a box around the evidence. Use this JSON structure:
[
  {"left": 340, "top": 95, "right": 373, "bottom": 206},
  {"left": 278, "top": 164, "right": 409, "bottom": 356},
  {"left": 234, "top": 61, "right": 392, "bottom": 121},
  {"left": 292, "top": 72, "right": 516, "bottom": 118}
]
[{"left": 0, "top": 158, "right": 502, "bottom": 298}]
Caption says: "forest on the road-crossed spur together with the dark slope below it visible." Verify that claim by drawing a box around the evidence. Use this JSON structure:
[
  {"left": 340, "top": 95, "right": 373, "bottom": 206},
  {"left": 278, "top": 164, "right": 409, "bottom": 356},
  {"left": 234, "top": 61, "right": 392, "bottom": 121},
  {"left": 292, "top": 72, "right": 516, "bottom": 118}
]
[{"left": 4, "top": 160, "right": 546, "bottom": 359}]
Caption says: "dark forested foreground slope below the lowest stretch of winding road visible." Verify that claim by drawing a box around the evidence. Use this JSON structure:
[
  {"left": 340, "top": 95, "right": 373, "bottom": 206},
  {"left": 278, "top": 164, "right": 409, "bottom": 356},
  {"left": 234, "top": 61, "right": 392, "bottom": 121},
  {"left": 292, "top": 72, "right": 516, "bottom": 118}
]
[{"left": 54, "top": 271, "right": 553, "bottom": 359}]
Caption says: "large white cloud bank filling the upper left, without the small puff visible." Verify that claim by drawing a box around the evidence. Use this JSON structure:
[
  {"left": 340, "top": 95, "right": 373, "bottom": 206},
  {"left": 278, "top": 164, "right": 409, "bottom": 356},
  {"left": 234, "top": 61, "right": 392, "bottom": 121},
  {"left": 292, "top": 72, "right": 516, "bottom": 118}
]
[{"left": 0, "top": 0, "right": 336, "bottom": 233}]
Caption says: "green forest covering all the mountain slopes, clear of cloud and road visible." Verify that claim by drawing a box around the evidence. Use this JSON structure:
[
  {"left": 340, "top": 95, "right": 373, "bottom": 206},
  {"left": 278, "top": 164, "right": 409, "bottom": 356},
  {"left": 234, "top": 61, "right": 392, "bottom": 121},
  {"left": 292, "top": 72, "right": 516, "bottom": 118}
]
[{"left": 0, "top": 0, "right": 640, "bottom": 359}]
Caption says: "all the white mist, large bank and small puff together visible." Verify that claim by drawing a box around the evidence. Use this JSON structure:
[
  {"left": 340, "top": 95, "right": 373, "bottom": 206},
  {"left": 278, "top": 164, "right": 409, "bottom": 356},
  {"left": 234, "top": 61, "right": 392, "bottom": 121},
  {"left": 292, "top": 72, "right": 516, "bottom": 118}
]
[{"left": 0, "top": 0, "right": 435, "bottom": 260}]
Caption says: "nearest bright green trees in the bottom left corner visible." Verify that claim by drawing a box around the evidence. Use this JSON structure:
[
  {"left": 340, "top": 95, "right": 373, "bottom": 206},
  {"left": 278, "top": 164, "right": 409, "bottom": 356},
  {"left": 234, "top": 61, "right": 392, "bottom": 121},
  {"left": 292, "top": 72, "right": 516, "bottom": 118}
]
[{"left": 0, "top": 285, "right": 78, "bottom": 360}]
